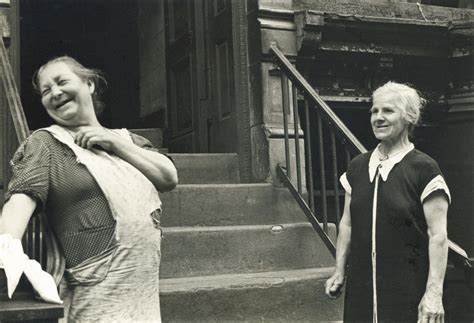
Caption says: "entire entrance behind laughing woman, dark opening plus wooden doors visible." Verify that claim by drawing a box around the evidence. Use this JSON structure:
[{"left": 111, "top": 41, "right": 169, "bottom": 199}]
[{"left": 18, "top": 0, "right": 238, "bottom": 153}]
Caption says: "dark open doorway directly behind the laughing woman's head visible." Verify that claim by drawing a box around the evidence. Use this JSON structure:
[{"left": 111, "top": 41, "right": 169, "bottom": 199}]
[{"left": 19, "top": 0, "right": 141, "bottom": 130}]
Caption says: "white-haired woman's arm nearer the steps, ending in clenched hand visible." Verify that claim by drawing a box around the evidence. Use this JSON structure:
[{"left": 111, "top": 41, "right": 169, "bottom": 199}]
[{"left": 324, "top": 192, "right": 351, "bottom": 299}]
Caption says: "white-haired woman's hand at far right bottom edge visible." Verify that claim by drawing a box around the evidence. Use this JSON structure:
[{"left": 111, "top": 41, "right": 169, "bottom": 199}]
[{"left": 418, "top": 285, "right": 444, "bottom": 323}]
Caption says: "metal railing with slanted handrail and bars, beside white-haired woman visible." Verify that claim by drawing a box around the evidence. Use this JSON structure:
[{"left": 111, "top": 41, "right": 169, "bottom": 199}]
[{"left": 270, "top": 43, "right": 367, "bottom": 257}]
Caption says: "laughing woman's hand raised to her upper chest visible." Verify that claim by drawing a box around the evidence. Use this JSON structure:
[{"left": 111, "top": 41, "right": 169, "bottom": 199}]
[{"left": 74, "top": 126, "right": 123, "bottom": 152}]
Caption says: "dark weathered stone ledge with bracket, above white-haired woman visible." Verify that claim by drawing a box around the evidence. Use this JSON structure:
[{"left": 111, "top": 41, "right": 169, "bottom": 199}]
[{"left": 295, "top": 10, "right": 450, "bottom": 57}]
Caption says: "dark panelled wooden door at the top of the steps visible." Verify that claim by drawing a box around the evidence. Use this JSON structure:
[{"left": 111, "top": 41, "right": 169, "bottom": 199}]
[{"left": 166, "top": 0, "right": 237, "bottom": 152}]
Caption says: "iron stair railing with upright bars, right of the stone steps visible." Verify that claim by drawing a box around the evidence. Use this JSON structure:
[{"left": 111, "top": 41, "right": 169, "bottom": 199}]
[{"left": 270, "top": 43, "right": 367, "bottom": 256}]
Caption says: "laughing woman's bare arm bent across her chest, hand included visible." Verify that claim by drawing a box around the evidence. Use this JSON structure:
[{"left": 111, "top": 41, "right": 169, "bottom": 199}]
[{"left": 74, "top": 127, "right": 178, "bottom": 192}]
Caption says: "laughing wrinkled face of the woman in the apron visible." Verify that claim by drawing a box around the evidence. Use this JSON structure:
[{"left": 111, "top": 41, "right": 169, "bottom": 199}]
[{"left": 38, "top": 62, "right": 96, "bottom": 126}]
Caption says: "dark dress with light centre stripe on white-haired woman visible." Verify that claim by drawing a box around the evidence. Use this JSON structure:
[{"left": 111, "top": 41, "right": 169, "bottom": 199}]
[{"left": 344, "top": 149, "right": 441, "bottom": 322}]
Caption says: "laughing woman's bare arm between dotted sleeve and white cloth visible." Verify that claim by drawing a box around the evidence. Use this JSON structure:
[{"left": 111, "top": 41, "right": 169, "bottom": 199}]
[{"left": 0, "top": 193, "right": 37, "bottom": 239}]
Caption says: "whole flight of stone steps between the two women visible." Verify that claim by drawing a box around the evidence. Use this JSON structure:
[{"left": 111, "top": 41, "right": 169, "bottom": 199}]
[{"left": 160, "top": 154, "right": 343, "bottom": 322}]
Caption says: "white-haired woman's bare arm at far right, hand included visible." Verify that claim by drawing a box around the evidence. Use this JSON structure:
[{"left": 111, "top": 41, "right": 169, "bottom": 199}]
[{"left": 418, "top": 190, "right": 448, "bottom": 322}]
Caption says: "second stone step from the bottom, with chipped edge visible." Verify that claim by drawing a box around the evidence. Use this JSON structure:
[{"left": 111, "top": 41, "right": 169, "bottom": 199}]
[{"left": 160, "top": 222, "right": 335, "bottom": 278}]
